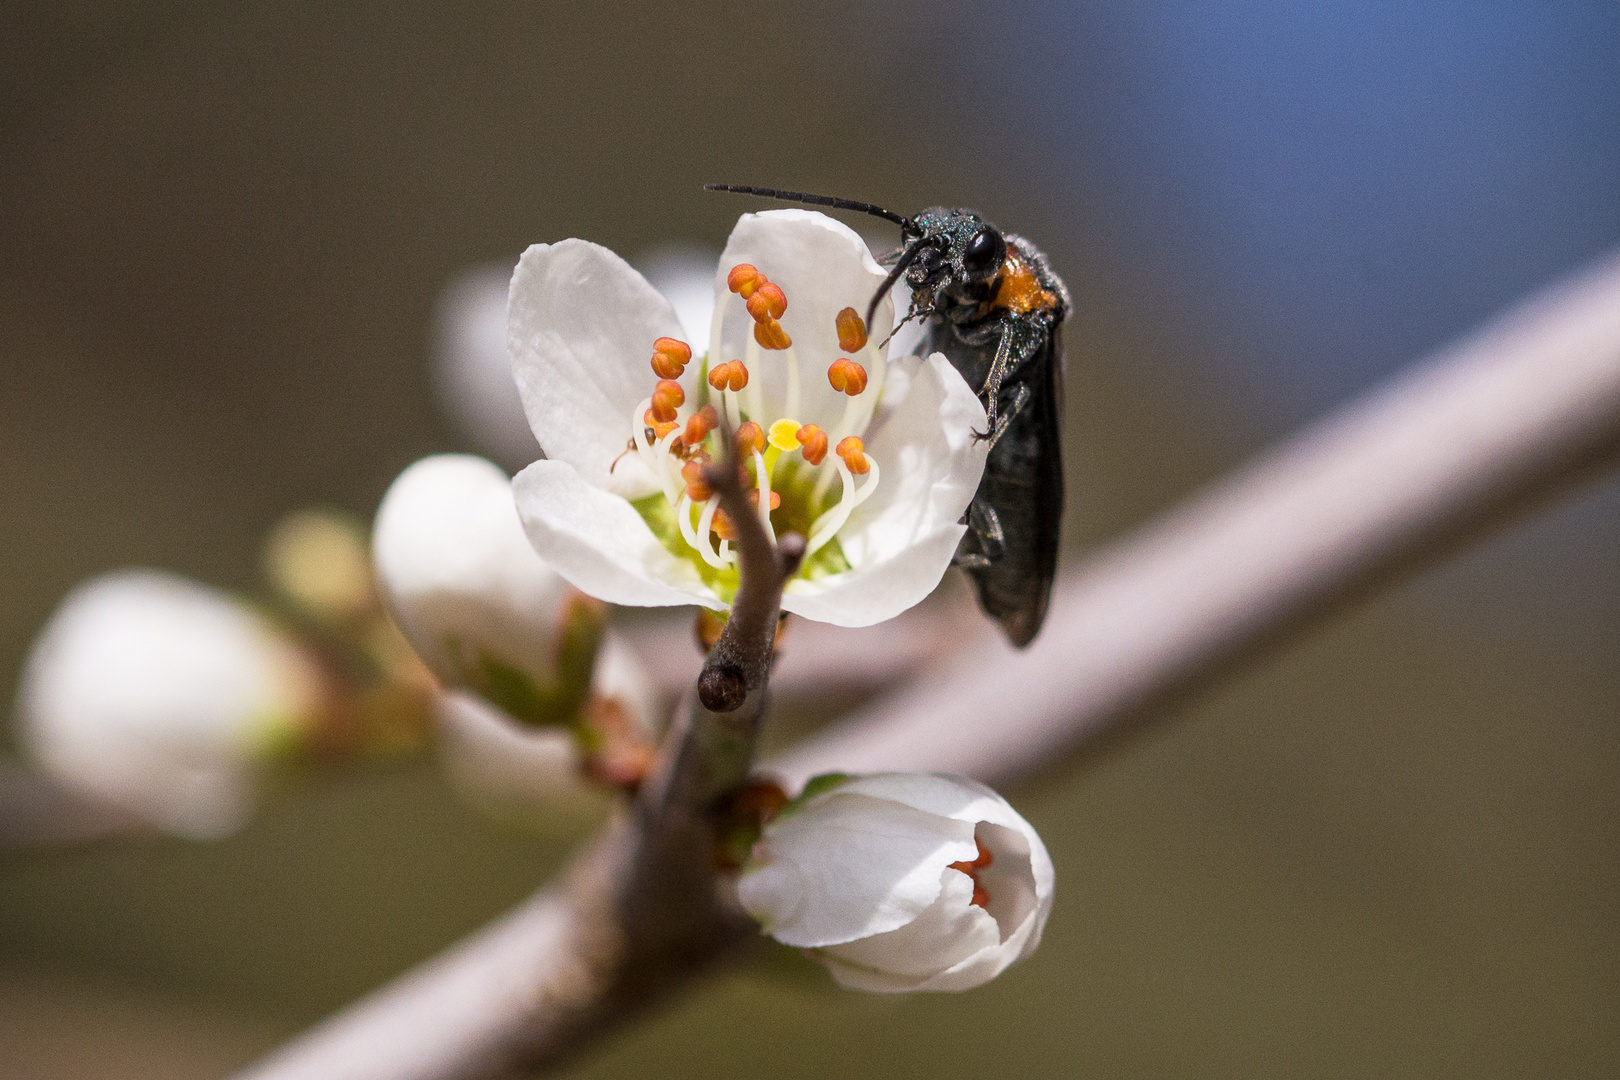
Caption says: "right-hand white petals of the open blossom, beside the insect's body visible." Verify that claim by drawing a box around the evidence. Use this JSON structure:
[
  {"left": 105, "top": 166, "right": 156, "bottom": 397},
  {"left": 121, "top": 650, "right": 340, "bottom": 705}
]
[{"left": 782, "top": 353, "right": 988, "bottom": 627}]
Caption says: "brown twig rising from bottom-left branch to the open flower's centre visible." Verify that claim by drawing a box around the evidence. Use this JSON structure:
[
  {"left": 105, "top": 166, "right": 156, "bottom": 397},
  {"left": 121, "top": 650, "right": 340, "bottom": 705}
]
[{"left": 243, "top": 443, "right": 804, "bottom": 1080}]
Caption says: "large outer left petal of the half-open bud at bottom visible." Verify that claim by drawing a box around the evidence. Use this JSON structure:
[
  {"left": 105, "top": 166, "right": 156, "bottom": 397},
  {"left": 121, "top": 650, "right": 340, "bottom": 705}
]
[{"left": 737, "top": 789, "right": 977, "bottom": 947}]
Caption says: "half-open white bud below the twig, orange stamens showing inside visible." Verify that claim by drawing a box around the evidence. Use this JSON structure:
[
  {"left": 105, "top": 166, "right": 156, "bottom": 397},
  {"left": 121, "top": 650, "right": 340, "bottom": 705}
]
[{"left": 737, "top": 772, "right": 1053, "bottom": 993}]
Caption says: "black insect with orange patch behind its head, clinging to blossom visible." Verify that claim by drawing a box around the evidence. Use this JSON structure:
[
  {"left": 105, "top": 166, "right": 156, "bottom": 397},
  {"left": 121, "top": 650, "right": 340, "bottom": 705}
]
[{"left": 708, "top": 185, "right": 1071, "bottom": 646}]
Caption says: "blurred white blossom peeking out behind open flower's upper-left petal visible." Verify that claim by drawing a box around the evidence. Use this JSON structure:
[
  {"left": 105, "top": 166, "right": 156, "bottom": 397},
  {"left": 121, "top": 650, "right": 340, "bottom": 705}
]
[{"left": 433, "top": 262, "right": 539, "bottom": 471}]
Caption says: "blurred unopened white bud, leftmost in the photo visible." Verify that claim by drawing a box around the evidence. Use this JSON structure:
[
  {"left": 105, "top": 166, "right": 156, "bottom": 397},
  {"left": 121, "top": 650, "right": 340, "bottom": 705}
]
[{"left": 18, "top": 570, "right": 319, "bottom": 839}]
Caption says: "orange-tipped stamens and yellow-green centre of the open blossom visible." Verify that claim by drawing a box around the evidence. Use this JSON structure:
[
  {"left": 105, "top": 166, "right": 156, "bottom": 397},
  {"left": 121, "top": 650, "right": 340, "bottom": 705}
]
[{"left": 627, "top": 262, "right": 886, "bottom": 601}]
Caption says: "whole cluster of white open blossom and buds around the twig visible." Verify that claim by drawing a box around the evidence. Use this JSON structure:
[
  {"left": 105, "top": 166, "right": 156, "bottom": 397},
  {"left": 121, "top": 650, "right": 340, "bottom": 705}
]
[{"left": 18, "top": 210, "right": 1053, "bottom": 993}]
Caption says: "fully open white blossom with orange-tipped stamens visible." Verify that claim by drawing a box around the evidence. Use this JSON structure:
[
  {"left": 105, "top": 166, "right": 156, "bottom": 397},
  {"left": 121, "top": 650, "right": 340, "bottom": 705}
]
[{"left": 507, "top": 210, "right": 987, "bottom": 627}]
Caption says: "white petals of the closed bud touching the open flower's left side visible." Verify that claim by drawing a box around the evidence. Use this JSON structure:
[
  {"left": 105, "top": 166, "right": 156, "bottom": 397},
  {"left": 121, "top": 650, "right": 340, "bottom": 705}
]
[{"left": 373, "top": 453, "right": 572, "bottom": 687}]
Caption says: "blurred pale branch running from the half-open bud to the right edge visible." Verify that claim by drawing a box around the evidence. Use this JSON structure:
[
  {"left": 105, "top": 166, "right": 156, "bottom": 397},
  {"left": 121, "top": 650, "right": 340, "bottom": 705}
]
[{"left": 768, "top": 253, "right": 1620, "bottom": 785}]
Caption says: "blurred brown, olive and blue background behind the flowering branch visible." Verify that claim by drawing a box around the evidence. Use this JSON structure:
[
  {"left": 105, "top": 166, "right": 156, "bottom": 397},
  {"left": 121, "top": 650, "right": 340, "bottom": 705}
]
[{"left": 0, "top": 0, "right": 1620, "bottom": 1080}]
